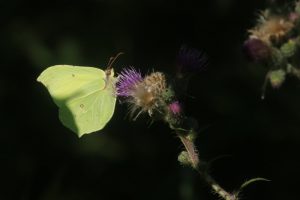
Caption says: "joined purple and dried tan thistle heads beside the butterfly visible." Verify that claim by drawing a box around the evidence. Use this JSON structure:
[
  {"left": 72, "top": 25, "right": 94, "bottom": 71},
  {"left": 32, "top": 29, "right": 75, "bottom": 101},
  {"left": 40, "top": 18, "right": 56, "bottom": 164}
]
[{"left": 116, "top": 69, "right": 167, "bottom": 119}]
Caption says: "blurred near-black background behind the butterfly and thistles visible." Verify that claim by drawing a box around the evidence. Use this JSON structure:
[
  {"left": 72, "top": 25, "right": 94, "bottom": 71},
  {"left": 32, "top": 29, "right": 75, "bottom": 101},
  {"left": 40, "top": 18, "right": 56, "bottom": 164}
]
[{"left": 0, "top": 0, "right": 300, "bottom": 200}]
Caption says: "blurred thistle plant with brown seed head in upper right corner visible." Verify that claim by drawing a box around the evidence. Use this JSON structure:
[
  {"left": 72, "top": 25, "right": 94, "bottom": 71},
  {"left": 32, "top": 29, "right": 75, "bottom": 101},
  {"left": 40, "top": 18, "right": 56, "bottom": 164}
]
[{"left": 244, "top": 1, "right": 300, "bottom": 99}]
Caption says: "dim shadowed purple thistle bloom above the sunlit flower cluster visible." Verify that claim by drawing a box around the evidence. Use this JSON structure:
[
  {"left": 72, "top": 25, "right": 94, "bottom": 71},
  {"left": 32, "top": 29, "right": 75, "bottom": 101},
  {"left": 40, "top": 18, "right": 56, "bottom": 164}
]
[{"left": 176, "top": 45, "right": 207, "bottom": 73}]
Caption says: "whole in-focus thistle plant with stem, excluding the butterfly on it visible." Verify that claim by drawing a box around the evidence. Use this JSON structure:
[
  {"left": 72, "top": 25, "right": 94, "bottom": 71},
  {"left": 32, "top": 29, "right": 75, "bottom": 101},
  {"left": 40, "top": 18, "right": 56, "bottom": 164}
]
[{"left": 116, "top": 46, "right": 266, "bottom": 200}]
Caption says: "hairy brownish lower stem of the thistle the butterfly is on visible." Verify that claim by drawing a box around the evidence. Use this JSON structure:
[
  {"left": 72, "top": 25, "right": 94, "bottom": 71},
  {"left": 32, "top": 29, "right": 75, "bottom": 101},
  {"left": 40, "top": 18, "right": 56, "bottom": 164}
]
[{"left": 177, "top": 132, "right": 238, "bottom": 200}]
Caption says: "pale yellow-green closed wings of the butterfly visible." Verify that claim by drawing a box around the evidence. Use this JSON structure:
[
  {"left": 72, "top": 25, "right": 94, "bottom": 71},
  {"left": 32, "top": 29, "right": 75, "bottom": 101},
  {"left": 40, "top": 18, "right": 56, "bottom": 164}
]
[{"left": 37, "top": 65, "right": 116, "bottom": 137}]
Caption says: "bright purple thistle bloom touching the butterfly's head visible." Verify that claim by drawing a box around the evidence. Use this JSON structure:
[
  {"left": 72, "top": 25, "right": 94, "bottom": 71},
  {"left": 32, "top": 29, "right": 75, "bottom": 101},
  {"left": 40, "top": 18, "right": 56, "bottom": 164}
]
[{"left": 116, "top": 68, "right": 143, "bottom": 97}]
